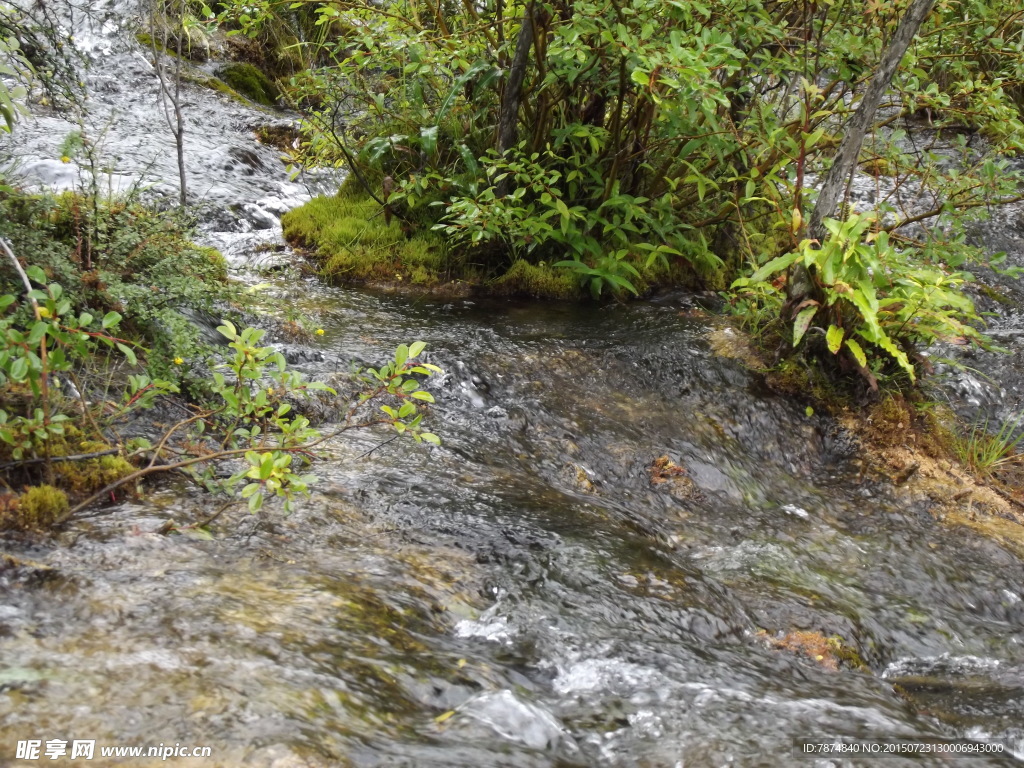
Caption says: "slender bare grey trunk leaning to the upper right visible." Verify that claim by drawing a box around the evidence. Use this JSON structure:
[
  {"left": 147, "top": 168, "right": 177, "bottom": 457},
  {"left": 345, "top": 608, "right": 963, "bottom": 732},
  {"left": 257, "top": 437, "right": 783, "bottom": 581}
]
[{"left": 787, "top": 0, "right": 935, "bottom": 308}]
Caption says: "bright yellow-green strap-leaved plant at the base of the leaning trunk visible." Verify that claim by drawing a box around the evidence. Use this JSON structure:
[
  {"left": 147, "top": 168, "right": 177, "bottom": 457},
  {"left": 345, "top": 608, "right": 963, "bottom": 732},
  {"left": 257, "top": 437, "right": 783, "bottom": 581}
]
[{"left": 733, "top": 214, "right": 985, "bottom": 387}]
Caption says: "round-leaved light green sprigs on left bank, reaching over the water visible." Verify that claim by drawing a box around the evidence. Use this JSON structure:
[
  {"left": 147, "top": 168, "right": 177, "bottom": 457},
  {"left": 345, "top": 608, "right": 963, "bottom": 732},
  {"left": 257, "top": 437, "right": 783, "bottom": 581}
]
[{"left": 0, "top": 274, "right": 440, "bottom": 528}]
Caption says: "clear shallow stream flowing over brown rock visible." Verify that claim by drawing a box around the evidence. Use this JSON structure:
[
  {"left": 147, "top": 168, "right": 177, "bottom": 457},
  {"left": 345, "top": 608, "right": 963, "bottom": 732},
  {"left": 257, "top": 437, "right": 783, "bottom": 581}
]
[{"left": 0, "top": 6, "right": 1024, "bottom": 768}]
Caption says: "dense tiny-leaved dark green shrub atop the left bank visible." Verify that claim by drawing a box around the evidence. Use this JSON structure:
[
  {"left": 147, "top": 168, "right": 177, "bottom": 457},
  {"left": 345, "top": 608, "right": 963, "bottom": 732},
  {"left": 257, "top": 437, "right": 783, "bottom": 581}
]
[{"left": 0, "top": 189, "right": 234, "bottom": 383}]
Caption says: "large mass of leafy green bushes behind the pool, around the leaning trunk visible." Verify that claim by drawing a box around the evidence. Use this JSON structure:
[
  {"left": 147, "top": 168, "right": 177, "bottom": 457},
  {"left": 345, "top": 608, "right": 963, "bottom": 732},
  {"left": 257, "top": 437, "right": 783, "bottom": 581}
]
[{"left": 209, "top": 0, "right": 1024, "bottom": 309}]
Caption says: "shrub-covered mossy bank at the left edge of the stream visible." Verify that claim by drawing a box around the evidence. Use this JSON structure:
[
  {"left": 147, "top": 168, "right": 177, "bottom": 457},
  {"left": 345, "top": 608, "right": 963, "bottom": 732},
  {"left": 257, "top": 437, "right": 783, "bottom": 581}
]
[{"left": 0, "top": 189, "right": 234, "bottom": 531}]
